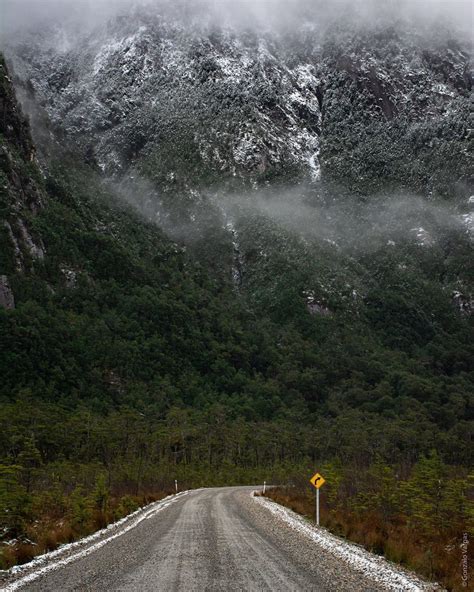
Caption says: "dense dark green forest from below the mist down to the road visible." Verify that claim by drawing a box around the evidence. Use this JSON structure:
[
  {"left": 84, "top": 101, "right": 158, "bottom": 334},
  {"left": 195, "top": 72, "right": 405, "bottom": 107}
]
[{"left": 0, "top": 42, "right": 474, "bottom": 588}]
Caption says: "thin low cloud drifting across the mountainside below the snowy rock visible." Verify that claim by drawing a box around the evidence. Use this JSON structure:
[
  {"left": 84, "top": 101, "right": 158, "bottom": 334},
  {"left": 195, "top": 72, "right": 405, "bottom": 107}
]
[{"left": 215, "top": 187, "right": 470, "bottom": 254}]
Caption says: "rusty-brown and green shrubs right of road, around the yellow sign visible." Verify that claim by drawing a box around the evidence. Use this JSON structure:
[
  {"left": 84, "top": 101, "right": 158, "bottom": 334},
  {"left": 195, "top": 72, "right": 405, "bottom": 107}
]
[{"left": 267, "top": 451, "right": 474, "bottom": 591}]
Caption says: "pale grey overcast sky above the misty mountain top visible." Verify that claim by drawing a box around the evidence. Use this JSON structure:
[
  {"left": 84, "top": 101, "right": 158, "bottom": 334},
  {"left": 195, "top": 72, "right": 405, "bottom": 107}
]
[{"left": 0, "top": 0, "right": 473, "bottom": 34}]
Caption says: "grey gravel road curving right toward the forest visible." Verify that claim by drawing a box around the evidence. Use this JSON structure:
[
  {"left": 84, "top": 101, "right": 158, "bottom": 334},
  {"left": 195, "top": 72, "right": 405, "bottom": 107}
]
[{"left": 2, "top": 487, "right": 426, "bottom": 592}]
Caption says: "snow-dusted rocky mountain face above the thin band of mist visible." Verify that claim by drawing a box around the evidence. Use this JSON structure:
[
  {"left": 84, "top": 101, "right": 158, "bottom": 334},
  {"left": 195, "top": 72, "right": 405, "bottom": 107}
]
[{"left": 8, "top": 9, "right": 472, "bottom": 195}]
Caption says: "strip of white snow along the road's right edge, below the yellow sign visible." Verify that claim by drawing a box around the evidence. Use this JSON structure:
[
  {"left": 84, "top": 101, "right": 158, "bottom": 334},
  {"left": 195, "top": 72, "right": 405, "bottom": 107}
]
[{"left": 252, "top": 492, "right": 444, "bottom": 592}]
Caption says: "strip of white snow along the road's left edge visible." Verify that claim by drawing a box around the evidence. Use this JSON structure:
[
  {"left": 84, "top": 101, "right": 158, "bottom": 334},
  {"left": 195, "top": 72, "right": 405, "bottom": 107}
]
[{"left": 0, "top": 491, "right": 189, "bottom": 592}]
